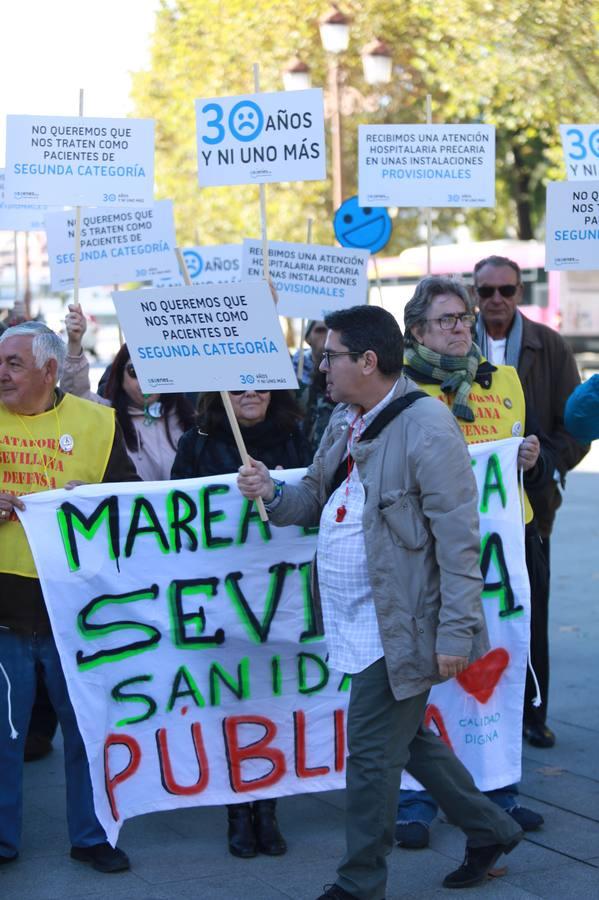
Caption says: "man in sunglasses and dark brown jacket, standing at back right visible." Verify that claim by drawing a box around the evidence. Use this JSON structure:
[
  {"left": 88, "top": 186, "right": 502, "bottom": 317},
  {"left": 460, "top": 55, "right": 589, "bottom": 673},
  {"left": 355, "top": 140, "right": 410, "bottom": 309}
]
[{"left": 474, "top": 256, "right": 589, "bottom": 748}]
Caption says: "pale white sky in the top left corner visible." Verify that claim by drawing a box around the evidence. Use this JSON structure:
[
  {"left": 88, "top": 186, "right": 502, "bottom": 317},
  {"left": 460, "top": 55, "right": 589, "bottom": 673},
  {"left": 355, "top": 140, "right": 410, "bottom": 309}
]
[{"left": 0, "top": 0, "right": 160, "bottom": 167}]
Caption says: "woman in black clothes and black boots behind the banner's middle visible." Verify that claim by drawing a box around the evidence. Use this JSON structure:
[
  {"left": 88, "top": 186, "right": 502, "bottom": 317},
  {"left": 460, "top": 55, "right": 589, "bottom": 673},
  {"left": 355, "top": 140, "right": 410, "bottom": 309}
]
[{"left": 171, "top": 390, "right": 312, "bottom": 859}]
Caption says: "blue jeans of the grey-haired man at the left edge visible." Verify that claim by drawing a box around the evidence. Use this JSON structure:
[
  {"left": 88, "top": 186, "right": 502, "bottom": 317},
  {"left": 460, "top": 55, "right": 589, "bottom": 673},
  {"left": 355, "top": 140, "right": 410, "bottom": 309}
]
[{"left": 0, "top": 627, "right": 106, "bottom": 856}]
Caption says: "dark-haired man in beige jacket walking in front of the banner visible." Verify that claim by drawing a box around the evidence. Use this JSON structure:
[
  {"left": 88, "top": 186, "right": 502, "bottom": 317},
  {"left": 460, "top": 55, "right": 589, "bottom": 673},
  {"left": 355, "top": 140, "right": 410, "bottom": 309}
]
[{"left": 238, "top": 305, "right": 522, "bottom": 900}]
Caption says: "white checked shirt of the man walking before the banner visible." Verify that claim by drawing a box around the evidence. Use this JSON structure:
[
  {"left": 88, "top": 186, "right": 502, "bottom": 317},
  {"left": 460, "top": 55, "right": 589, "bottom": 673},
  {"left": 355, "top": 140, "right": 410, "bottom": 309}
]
[{"left": 318, "top": 385, "right": 396, "bottom": 674}]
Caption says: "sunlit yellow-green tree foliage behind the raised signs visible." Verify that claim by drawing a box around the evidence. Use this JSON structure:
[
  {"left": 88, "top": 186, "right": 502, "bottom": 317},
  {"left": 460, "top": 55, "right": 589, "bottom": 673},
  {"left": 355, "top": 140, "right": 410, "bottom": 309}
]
[{"left": 133, "top": 0, "right": 599, "bottom": 253}]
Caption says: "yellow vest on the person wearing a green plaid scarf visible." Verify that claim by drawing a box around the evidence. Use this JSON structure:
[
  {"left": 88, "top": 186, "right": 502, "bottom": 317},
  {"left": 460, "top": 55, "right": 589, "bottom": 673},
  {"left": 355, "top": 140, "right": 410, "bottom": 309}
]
[{"left": 411, "top": 366, "right": 533, "bottom": 523}]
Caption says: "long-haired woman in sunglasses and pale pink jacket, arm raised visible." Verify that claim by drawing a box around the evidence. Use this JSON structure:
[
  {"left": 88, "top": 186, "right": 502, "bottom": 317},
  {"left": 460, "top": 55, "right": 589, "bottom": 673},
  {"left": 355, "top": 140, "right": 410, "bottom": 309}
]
[{"left": 61, "top": 306, "right": 195, "bottom": 481}]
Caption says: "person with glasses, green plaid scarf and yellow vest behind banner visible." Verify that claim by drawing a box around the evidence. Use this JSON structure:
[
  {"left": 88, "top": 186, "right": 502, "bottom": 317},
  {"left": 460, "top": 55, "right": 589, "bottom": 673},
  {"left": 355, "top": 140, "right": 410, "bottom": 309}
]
[{"left": 395, "top": 276, "right": 554, "bottom": 849}]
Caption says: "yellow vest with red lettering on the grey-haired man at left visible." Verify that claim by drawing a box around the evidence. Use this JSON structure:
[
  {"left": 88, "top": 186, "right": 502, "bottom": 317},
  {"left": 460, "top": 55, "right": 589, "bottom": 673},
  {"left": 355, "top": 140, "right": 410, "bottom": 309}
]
[{"left": 0, "top": 394, "right": 115, "bottom": 578}]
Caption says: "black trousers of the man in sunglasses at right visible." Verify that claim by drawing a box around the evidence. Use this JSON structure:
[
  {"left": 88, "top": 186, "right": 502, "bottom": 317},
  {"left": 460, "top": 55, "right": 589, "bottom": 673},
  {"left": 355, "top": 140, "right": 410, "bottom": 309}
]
[{"left": 524, "top": 526, "right": 549, "bottom": 726}]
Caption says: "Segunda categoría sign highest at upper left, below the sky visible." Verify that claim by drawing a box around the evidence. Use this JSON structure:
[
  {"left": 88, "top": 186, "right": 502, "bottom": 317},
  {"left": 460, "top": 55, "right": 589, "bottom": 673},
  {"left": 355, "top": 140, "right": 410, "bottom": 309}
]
[{"left": 6, "top": 116, "right": 154, "bottom": 207}]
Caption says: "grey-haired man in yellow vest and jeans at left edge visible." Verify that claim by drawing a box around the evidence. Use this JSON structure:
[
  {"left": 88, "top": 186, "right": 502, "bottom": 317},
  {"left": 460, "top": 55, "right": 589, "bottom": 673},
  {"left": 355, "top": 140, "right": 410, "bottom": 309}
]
[{"left": 0, "top": 322, "right": 138, "bottom": 872}]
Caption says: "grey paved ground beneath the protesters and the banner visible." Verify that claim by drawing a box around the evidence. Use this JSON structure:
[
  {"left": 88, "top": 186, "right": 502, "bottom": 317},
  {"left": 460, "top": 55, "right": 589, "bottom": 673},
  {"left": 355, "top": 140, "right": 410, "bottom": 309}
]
[{"left": 0, "top": 442, "right": 599, "bottom": 900}]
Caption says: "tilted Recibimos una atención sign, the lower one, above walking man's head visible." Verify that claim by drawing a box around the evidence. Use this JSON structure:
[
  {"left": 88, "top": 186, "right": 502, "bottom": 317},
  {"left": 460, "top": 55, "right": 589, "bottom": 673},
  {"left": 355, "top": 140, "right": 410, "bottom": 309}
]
[{"left": 242, "top": 240, "right": 370, "bottom": 319}]
